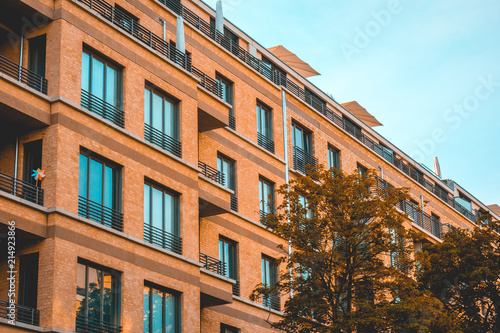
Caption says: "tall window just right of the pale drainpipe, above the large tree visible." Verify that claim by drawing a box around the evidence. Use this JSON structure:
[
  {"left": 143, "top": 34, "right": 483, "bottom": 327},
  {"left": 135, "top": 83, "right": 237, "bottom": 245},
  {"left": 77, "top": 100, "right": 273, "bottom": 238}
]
[{"left": 292, "top": 124, "right": 318, "bottom": 174}]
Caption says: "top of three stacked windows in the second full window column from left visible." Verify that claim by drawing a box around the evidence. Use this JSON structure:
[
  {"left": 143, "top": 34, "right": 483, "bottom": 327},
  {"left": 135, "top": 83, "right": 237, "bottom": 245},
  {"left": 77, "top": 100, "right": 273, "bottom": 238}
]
[{"left": 144, "top": 87, "right": 182, "bottom": 157}]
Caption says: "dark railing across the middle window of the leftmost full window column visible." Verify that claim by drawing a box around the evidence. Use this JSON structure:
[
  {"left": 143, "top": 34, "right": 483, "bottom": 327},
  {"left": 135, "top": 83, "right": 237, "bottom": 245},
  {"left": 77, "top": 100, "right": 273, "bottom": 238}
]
[{"left": 78, "top": 196, "right": 123, "bottom": 231}]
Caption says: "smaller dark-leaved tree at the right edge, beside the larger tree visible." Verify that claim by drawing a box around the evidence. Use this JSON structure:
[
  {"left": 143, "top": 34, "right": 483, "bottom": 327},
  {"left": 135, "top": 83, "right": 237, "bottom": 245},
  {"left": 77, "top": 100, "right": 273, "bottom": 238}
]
[{"left": 417, "top": 218, "right": 500, "bottom": 333}]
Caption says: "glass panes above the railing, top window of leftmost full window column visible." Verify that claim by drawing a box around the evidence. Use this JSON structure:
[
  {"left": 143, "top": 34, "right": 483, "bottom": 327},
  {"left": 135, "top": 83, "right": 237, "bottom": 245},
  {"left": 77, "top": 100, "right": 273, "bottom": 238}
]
[{"left": 82, "top": 50, "right": 122, "bottom": 108}]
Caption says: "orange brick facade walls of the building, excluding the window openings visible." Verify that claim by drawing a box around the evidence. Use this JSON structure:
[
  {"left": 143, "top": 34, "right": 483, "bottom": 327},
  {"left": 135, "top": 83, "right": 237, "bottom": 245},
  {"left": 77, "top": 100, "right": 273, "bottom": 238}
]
[{"left": 0, "top": 0, "right": 496, "bottom": 333}]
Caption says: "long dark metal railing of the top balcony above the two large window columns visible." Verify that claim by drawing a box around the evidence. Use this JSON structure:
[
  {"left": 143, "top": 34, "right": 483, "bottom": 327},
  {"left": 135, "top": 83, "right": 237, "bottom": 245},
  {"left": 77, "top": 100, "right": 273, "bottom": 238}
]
[{"left": 75, "top": 0, "right": 222, "bottom": 98}]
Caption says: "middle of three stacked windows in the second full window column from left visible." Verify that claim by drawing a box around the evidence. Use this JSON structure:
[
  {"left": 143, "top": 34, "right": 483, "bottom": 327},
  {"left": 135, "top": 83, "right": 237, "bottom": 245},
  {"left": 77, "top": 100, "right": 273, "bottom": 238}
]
[{"left": 144, "top": 184, "right": 182, "bottom": 254}]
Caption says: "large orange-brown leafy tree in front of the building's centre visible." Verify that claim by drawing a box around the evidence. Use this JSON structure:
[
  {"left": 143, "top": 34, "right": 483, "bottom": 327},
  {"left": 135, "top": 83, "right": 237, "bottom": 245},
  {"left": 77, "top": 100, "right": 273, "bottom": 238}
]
[{"left": 251, "top": 167, "right": 454, "bottom": 333}]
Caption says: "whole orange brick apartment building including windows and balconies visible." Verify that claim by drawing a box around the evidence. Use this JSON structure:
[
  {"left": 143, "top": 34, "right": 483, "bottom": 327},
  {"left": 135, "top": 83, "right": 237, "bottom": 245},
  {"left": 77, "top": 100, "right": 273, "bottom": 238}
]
[{"left": 0, "top": 0, "right": 499, "bottom": 333}]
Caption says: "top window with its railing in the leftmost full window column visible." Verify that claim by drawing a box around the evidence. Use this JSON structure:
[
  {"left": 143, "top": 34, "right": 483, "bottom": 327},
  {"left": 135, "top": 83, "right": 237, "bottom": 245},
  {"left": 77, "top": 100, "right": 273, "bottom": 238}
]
[{"left": 82, "top": 50, "right": 124, "bottom": 127}]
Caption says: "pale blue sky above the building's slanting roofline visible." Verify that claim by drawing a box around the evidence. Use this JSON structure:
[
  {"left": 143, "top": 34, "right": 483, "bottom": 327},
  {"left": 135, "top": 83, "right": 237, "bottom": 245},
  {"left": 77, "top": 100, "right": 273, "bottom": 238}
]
[{"left": 205, "top": 0, "right": 500, "bottom": 204}]
